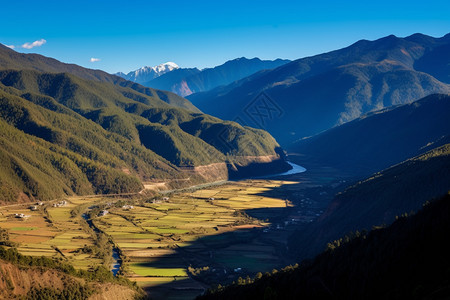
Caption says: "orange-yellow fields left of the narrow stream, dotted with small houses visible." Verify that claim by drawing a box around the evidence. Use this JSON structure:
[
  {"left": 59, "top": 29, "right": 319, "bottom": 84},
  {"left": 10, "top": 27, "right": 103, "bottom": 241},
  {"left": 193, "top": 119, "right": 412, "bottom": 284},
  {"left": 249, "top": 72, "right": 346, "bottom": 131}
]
[{"left": 0, "top": 197, "right": 105, "bottom": 269}]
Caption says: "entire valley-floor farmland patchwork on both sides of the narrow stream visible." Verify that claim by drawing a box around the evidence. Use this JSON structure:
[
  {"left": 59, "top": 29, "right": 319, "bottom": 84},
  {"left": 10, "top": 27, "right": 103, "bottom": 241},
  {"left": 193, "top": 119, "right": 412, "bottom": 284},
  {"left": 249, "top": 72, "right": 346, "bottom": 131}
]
[{"left": 0, "top": 180, "right": 312, "bottom": 298}]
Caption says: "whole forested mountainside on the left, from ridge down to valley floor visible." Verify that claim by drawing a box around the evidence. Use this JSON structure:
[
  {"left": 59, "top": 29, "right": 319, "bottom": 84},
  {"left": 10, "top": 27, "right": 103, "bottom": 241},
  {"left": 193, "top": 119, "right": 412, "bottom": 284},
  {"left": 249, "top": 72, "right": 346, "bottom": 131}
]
[{"left": 0, "top": 45, "right": 289, "bottom": 203}]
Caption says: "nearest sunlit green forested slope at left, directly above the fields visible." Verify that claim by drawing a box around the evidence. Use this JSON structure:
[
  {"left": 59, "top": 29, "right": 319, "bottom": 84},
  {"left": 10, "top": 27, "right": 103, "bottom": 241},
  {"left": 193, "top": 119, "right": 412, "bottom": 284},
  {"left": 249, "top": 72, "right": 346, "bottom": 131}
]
[{"left": 0, "top": 92, "right": 171, "bottom": 201}]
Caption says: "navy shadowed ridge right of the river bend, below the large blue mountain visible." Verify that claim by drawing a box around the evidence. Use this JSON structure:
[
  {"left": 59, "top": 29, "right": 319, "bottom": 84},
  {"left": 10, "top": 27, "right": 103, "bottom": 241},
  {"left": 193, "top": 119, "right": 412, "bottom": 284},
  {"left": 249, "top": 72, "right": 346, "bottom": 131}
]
[{"left": 288, "top": 95, "right": 450, "bottom": 176}]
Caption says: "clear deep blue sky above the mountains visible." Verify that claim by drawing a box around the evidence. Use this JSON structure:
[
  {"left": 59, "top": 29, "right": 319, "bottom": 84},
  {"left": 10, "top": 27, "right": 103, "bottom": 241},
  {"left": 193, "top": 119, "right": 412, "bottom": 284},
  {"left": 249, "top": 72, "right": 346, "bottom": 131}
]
[{"left": 0, "top": 0, "right": 450, "bottom": 72}]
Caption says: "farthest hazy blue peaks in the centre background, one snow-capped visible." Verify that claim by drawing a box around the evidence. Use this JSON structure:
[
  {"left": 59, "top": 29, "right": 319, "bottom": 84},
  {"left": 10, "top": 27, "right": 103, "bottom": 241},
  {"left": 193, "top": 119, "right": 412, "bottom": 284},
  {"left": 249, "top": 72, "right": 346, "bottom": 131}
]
[{"left": 116, "top": 57, "right": 290, "bottom": 97}]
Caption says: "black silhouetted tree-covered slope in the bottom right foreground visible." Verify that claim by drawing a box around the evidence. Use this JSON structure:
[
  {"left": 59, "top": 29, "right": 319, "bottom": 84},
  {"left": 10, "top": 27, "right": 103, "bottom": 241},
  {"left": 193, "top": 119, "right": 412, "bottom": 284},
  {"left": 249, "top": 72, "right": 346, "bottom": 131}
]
[{"left": 198, "top": 194, "right": 450, "bottom": 299}]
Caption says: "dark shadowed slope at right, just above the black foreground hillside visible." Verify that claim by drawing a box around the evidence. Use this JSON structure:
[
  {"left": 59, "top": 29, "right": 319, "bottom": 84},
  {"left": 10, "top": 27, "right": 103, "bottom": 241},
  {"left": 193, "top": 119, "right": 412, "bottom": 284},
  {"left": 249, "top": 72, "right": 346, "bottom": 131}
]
[{"left": 289, "top": 144, "right": 450, "bottom": 258}]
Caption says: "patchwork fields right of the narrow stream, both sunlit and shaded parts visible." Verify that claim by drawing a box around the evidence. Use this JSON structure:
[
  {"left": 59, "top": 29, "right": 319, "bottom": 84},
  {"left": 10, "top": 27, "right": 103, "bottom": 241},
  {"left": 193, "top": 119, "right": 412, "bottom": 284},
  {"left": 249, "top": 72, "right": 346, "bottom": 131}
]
[{"left": 89, "top": 180, "right": 294, "bottom": 296}]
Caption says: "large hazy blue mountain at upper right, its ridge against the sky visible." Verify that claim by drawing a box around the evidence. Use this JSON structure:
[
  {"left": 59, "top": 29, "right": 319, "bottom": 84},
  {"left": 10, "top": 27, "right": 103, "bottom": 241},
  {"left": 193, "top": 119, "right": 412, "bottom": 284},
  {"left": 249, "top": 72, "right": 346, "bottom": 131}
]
[{"left": 188, "top": 34, "right": 450, "bottom": 145}]
